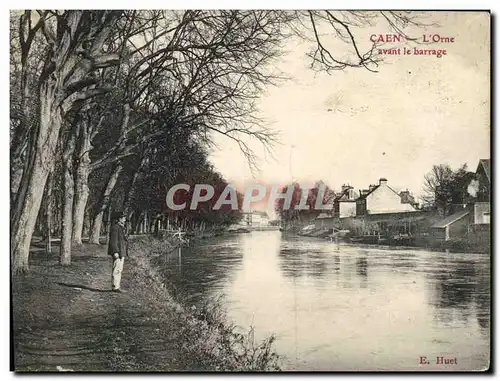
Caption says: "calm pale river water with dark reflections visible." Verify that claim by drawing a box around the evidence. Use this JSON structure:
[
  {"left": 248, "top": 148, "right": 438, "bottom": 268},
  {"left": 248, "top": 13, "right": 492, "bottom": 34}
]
[{"left": 159, "top": 231, "right": 490, "bottom": 371}]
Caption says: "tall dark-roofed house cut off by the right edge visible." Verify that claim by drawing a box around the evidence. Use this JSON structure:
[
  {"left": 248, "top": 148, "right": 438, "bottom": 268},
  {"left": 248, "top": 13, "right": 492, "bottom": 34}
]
[{"left": 472, "top": 159, "right": 491, "bottom": 225}]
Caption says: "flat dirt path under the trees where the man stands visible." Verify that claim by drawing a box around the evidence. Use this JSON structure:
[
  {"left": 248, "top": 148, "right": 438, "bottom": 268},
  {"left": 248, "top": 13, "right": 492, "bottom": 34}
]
[{"left": 12, "top": 245, "right": 179, "bottom": 371}]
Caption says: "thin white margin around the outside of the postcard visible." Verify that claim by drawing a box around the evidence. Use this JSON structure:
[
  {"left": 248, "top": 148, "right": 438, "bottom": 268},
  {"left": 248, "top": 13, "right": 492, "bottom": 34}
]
[{"left": 0, "top": 0, "right": 500, "bottom": 380}]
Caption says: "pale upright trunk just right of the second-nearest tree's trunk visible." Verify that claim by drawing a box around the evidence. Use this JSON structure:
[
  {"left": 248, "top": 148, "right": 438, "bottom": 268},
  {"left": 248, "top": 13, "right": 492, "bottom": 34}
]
[{"left": 72, "top": 121, "right": 92, "bottom": 245}]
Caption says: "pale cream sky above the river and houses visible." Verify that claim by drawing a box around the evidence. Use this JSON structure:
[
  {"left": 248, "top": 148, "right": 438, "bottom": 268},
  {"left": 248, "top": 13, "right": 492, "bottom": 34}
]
[{"left": 211, "top": 12, "right": 490, "bottom": 214}]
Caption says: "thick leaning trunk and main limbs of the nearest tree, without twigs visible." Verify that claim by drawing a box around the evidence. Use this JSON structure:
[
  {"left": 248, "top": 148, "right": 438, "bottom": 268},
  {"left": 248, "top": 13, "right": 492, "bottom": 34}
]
[{"left": 11, "top": 11, "right": 121, "bottom": 272}]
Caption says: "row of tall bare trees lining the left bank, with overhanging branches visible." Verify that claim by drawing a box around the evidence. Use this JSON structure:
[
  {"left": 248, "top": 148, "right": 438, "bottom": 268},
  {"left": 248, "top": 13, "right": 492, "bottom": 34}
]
[{"left": 10, "top": 10, "right": 415, "bottom": 272}]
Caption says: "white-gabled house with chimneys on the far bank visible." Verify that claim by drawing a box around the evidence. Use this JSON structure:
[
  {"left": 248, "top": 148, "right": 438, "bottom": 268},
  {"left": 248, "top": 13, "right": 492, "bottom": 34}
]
[{"left": 356, "top": 178, "right": 416, "bottom": 216}]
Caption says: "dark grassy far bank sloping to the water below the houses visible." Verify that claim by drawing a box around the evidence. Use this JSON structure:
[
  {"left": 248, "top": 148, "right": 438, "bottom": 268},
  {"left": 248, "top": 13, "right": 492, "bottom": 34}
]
[{"left": 286, "top": 208, "right": 491, "bottom": 253}]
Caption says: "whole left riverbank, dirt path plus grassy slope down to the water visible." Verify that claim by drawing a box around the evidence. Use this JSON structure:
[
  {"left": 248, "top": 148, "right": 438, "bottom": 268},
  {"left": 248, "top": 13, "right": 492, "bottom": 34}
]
[{"left": 12, "top": 238, "right": 279, "bottom": 372}]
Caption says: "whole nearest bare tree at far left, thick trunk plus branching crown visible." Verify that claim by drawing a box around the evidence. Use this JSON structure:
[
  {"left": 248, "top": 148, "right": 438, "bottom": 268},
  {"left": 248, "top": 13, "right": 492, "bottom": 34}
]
[{"left": 11, "top": 11, "right": 119, "bottom": 272}]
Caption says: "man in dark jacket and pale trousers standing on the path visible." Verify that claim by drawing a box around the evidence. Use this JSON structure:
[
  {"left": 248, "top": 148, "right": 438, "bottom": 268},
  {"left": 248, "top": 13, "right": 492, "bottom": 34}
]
[{"left": 108, "top": 213, "right": 128, "bottom": 292}]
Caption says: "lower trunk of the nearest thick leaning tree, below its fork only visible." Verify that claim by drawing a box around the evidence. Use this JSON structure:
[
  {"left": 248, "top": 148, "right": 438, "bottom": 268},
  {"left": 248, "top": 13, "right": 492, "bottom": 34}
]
[{"left": 11, "top": 80, "right": 62, "bottom": 273}]
